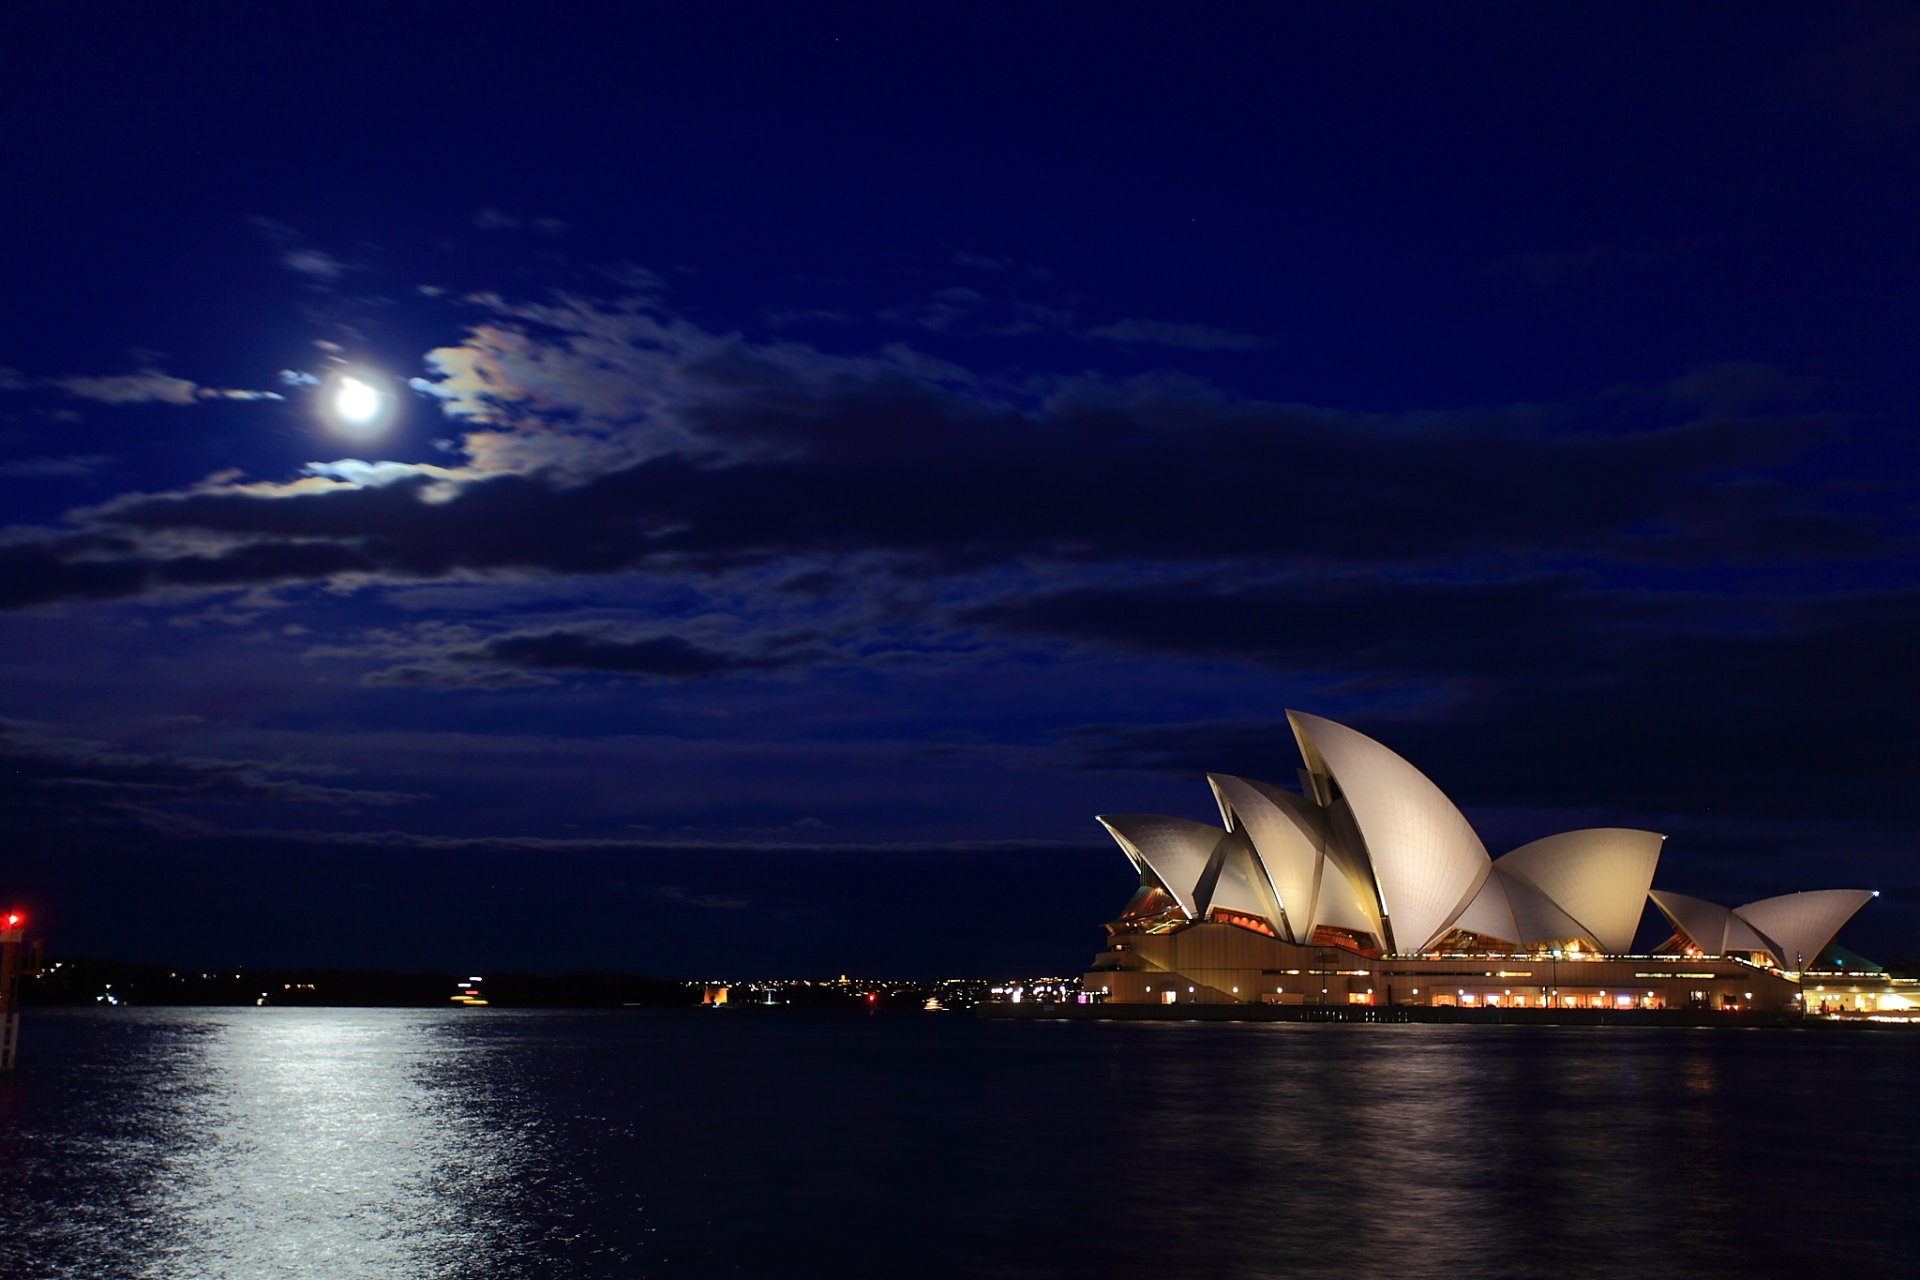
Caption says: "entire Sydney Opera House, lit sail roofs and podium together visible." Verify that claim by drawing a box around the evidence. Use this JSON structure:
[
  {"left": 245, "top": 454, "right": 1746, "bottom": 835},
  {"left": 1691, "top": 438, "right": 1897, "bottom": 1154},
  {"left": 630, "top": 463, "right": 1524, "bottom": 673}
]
[{"left": 1081, "top": 712, "right": 1874, "bottom": 1011}]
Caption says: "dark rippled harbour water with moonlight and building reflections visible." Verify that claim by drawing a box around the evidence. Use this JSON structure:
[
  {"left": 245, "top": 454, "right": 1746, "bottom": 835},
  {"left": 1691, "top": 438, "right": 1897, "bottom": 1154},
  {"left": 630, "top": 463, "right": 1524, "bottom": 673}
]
[{"left": 0, "top": 1007, "right": 1920, "bottom": 1280}]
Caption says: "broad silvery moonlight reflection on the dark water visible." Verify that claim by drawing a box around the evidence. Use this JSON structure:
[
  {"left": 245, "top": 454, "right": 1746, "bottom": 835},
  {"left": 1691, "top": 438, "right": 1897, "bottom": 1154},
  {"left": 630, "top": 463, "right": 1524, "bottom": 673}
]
[{"left": 154, "top": 1009, "right": 524, "bottom": 1278}]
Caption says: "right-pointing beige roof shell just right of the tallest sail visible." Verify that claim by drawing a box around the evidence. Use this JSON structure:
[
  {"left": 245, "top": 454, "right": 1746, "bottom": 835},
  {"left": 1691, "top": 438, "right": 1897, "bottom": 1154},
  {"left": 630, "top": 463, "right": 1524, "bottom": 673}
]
[{"left": 1494, "top": 827, "right": 1667, "bottom": 956}]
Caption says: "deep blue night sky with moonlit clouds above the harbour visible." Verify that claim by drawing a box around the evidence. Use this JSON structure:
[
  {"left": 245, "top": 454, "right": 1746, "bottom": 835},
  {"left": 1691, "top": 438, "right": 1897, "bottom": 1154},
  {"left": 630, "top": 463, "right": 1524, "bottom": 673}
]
[{"left": 0, "top": 4, "right": 1920, "bottom": 977}]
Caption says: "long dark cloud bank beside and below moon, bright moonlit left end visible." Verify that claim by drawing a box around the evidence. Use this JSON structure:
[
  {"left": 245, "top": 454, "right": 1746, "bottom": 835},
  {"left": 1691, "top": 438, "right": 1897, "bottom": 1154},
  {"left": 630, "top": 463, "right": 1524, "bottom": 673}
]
[{"left": 0, "top": 280, "right": 1889, "bottom": 626}]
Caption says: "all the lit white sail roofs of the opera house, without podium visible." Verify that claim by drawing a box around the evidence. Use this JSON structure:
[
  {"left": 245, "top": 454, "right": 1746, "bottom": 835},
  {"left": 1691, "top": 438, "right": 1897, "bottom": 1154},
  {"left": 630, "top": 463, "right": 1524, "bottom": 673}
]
[{"left": 1100, "top": 712, "right": 1872, "bottom": 969}]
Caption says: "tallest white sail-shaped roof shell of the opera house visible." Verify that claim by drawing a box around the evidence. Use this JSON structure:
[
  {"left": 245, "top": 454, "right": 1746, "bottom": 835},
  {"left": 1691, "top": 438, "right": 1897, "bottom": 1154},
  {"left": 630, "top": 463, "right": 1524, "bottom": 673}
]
[{"left": 1286, "top": 712, "right": 1492, "bottom": 954}]
